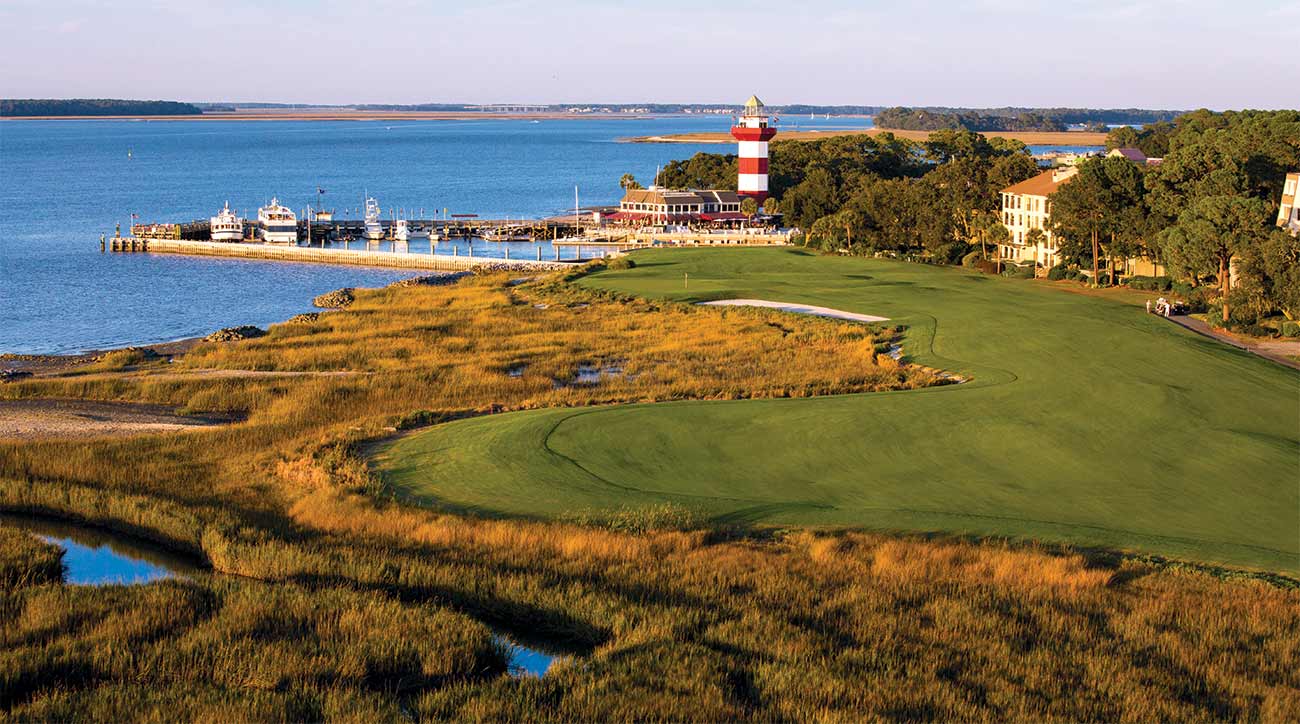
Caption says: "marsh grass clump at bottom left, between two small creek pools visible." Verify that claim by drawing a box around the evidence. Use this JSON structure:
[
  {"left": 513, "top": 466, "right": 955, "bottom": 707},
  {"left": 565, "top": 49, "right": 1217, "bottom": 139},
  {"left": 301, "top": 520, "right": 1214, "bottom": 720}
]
[{"left": 0, "top": 578, "right": 507, "bottom": 721}]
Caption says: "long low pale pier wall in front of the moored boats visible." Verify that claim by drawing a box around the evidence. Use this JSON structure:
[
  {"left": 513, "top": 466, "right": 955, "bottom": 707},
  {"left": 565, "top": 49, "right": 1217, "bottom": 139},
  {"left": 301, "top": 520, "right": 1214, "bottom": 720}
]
[{"left": 108, "top": 237, "right": 573, "bottom": 272}]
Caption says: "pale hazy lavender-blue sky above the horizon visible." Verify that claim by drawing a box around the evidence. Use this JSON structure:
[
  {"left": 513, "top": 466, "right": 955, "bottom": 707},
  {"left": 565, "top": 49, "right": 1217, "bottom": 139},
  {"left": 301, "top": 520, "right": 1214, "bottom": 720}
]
[{"left": 0, "top": 0, "right": 1300, "bottom": 108}]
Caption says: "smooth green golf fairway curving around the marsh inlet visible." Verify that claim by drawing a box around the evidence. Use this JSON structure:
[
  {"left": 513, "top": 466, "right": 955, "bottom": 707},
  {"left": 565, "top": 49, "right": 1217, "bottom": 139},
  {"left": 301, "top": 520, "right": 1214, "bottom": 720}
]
[{"left": 376, "top": 250, "right": 1300, "bottom": 572}]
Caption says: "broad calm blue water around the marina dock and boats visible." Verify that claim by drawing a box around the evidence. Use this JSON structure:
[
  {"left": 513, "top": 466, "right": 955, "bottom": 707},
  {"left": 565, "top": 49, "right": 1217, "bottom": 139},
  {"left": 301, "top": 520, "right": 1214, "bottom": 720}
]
[{"left": 0, "top": 117, "right": 852, "bottom": 352}]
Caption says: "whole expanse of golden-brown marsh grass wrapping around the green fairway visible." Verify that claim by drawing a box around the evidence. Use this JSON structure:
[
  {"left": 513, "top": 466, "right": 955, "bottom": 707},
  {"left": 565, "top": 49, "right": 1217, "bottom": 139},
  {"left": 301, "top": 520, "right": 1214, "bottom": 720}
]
[{"left": 0, "top": 270, "right": 1300, "bottom": 720}]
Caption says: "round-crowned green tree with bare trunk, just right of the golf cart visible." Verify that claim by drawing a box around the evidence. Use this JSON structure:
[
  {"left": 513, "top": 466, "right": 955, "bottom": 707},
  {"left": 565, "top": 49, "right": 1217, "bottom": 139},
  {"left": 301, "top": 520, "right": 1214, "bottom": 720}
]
[{"left": 1161, "top": 195, "right": 1271, "bottom": 322}]
